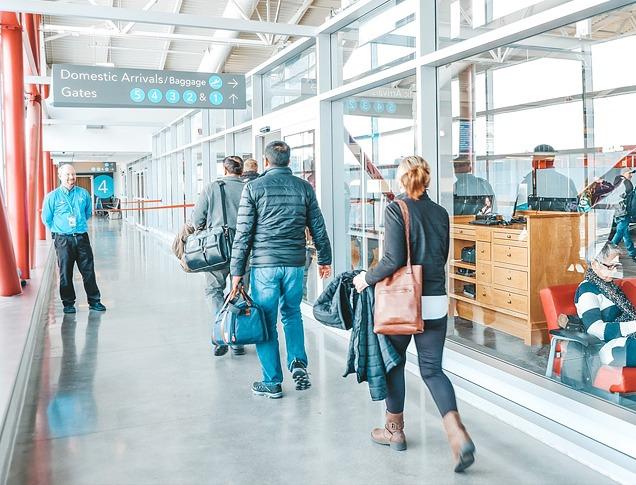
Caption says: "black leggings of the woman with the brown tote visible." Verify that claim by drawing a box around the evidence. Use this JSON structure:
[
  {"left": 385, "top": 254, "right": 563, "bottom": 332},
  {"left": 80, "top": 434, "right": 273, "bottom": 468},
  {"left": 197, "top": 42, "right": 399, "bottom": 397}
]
[{"left": 386, "top": 316, "right": 457, "bottom": 416}]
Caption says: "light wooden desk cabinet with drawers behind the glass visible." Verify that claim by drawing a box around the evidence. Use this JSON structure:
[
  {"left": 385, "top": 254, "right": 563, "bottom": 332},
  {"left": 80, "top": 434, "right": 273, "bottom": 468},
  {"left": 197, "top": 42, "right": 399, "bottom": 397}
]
[{"left": 449, "top": 212, "right": 585, "bottom": 345}]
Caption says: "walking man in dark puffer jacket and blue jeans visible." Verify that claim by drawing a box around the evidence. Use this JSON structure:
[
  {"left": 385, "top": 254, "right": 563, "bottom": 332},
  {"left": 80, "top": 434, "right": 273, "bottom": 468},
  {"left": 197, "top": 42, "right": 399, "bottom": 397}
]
[{"left": 230, "top": 141, "right": 331, "bottom": 398}]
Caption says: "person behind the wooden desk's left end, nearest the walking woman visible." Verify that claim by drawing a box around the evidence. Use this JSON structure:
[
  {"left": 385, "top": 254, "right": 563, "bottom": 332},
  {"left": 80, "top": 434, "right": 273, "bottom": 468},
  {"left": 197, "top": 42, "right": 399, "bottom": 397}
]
[{"left": 453, "top": 159, "right": 495, "bottom": 215}]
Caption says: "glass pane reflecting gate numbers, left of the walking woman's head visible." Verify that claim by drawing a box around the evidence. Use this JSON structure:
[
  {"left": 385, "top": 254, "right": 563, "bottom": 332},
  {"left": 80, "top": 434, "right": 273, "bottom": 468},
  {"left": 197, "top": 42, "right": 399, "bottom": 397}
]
[{"left": 338, "top": 76, "right": 415, "bottom": 269}]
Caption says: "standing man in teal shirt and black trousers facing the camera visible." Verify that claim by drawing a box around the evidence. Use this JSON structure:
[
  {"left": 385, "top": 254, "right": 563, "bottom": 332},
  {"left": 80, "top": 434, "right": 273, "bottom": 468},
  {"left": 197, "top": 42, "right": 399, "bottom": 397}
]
[{"left": 42, "top": 165, "right": 106, "bottom": 313}]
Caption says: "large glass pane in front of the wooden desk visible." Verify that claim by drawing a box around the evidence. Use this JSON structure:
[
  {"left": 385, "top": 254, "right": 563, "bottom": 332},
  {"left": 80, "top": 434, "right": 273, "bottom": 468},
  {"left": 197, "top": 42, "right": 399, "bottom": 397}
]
[{"left": 438, "top": 2, "right": 636, "bottom": 409}]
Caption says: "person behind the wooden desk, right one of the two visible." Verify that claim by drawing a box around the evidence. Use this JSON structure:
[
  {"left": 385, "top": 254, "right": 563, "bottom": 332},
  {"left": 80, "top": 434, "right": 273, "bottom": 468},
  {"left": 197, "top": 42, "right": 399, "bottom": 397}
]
[{"left": 517, "top": 145, "right": 578, "bottom": 210}]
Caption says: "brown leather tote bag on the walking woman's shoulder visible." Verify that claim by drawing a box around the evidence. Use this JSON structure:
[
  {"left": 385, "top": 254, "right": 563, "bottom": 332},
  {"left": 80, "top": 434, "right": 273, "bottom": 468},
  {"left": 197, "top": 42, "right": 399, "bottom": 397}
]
[{"left": 373, "top": 199, "right": 424, "bottom": 335}]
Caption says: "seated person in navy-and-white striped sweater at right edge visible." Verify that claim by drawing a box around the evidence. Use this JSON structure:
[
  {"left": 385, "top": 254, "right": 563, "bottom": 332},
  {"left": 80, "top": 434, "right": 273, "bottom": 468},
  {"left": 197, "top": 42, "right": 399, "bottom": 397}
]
[{"left": 574, "top": 243, "right": 636, "bottom": 367}]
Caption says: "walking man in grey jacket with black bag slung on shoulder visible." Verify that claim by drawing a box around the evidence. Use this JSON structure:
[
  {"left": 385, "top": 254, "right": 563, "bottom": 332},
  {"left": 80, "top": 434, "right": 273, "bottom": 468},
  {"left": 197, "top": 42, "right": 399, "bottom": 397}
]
[{"left": 192, "top": 156, "right": 247, "bottom": 356}]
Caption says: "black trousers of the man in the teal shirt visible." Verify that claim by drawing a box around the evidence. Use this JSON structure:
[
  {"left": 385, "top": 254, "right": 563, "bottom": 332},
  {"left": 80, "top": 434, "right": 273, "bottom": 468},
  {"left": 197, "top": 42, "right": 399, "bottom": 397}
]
[{"left": 53, "top": 233, "right": 101, "bottom": 306}]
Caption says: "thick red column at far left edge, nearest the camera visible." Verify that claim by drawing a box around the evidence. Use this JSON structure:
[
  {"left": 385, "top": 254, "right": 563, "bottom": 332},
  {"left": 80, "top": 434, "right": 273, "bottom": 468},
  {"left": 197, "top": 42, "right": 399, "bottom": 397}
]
[{"left": 0, "top": 12, "right": 30, "bottom": 279}]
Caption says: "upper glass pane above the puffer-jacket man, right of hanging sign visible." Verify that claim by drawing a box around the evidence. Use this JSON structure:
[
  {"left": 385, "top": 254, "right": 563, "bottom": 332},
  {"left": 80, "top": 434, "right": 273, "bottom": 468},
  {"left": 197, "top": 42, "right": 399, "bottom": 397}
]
[{"left": 263, "top": 46, "right": 316, "bottom": 113}]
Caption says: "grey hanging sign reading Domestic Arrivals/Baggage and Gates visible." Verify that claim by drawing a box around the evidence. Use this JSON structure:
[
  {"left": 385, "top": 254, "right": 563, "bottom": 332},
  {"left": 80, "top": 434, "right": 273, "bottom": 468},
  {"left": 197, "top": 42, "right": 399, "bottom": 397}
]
[{"left": 52, "top": 64, "right": 245, "bottom": 109}]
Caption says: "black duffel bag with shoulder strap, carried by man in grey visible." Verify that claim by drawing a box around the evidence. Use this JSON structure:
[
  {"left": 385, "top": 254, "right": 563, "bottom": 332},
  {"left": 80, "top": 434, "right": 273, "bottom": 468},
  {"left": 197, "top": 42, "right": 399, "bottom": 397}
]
[{"left": 183, "top": 180, "right": 235, "bottom": 273}]
